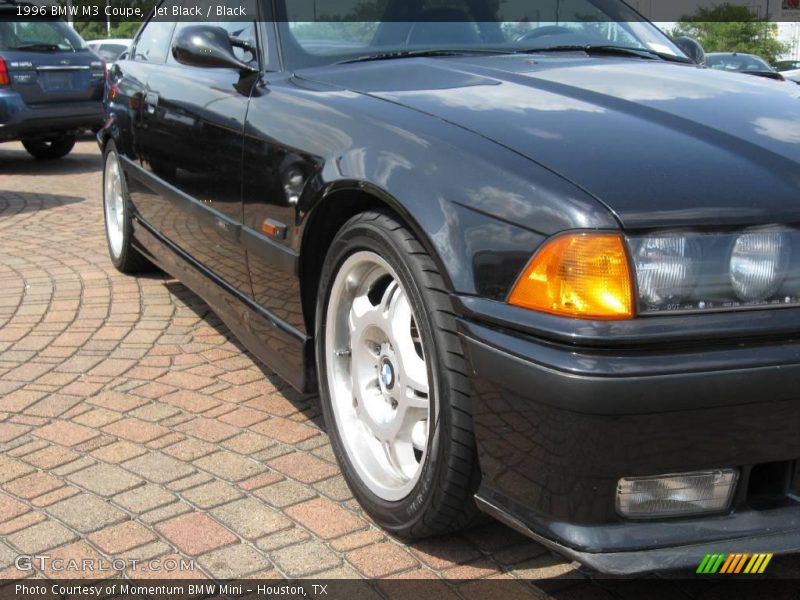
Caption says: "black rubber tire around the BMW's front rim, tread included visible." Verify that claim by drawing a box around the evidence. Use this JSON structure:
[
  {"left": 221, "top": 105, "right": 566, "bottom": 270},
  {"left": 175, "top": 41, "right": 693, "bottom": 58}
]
[{"left": 315, "top": 212, "right": 480, "bottom": 539}]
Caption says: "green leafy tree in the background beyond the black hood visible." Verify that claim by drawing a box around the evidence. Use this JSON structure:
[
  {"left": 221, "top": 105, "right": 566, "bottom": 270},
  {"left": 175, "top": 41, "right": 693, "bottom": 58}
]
[{"left": 671, "top": 3, "right": 789, "bottom": 64}]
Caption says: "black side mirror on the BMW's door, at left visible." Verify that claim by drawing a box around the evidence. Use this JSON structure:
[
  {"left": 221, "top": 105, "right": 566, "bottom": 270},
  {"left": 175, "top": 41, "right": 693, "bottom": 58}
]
[{"left": 172, "top": 25, "right": 256, "bottom": 73}]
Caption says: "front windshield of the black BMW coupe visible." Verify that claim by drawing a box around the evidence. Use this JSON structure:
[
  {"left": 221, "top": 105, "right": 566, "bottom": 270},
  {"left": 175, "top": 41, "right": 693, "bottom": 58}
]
[{"left": 278, "top": 0, "right": 686, "bottom": 68}]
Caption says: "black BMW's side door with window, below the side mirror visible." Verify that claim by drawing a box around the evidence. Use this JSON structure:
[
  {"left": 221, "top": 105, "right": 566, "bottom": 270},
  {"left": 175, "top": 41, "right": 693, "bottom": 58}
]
[{"left": 128, "top": 2, "right": 258, "bottom": 297}]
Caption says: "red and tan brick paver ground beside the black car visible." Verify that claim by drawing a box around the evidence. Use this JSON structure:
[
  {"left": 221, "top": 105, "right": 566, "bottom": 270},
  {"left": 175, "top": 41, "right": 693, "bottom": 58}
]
[{"left": 0, "top": 141, "right": 800, "bottom": 597}]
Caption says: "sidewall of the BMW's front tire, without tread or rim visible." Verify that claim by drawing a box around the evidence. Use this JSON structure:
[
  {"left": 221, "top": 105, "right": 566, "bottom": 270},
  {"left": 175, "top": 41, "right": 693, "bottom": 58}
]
[{"left": 315, "top": 213, "right": 449, "bottom": 532}]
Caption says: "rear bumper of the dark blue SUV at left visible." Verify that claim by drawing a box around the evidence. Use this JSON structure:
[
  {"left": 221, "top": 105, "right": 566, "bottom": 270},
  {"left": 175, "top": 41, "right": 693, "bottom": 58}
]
[{"left": 0, "top": 90, "right": 103, "bottom": 141}]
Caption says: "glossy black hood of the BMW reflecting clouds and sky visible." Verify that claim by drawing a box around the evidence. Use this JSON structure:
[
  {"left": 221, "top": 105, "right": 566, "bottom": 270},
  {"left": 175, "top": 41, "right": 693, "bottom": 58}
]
[{"left": 298, "top": 54, "right": 800, "bottom": 229}]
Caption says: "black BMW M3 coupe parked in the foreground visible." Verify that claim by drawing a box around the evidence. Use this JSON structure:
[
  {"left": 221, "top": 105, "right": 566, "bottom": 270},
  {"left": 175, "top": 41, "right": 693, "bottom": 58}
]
[{"left": 99, "top": 0, "right": 800, "bottom": 574}]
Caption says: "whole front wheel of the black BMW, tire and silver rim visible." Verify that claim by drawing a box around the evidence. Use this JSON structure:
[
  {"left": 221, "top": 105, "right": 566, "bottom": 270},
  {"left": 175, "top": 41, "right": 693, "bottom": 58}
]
[{"left": 316, "top": 212, "right": 479, "bottom": 538}]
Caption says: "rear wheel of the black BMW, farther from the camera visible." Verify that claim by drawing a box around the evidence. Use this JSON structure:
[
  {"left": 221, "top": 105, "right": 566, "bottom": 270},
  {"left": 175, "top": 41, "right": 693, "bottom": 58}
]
[{"left": 103, "top": 142, "right": 153, "bottom": 273}]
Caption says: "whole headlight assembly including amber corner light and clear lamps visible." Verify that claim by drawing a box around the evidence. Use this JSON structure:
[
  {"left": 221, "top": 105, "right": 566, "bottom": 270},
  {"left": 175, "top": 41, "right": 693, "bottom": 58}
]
[{"left": 508, "top": 226, "right": 800, "bottom": 320}]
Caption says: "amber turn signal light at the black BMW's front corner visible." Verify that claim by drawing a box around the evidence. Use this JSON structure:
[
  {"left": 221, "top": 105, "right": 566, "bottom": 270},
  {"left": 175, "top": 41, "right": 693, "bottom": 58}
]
[{"left": 508, "top": 233, "right": 633, "bottom": 320}]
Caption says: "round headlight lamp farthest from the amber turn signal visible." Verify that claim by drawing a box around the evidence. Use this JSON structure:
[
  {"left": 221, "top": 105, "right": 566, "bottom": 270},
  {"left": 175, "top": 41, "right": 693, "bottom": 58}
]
[{"left": 730, "top": 231, "right": 790, "bottom": 302}]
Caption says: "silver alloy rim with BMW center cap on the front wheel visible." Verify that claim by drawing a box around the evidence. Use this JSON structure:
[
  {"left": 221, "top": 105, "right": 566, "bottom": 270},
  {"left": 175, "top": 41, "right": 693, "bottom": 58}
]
[{"left": 325, "top": 250, "right": 431, "bottom": 501}]
